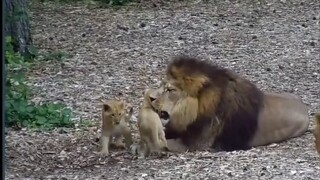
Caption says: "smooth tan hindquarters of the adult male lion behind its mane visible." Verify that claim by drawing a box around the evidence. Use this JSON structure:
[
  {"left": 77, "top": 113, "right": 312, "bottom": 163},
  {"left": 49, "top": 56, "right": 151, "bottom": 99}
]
[{"left": 250, "top": 92, "right": 309, "bottom": 147}]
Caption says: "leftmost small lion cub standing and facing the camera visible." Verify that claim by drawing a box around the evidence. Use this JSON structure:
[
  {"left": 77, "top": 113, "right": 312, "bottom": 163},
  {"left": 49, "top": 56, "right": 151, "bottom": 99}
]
[{"left": 100, "top": 100, "right": 133, "bottom": 155}]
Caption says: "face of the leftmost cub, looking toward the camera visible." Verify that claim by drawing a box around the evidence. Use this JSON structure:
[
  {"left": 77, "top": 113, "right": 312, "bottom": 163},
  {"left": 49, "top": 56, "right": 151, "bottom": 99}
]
[{"left": 103, "top": 100, "right": 126, "bottom": 125}]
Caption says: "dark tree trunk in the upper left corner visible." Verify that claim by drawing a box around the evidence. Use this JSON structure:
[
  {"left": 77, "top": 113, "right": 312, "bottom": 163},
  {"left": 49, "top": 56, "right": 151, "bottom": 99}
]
[{"left": 5, "top": 0, "right": 32, "bottom": 57}]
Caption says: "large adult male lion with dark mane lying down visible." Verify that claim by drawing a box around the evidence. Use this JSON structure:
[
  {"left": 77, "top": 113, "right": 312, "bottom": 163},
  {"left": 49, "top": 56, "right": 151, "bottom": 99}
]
[{"left": 150, "top": 56, "right": 309, "bottom": 151}]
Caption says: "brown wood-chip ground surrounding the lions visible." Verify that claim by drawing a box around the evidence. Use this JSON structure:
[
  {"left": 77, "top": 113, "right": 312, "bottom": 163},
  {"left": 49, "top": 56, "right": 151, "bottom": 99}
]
[{"left": 5, "top": 0, "right": 320, "bottom": 180}]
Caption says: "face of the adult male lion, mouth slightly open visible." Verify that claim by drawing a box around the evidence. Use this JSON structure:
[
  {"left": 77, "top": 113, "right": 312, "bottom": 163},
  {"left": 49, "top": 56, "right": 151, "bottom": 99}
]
[{"left": 150, "top": 81, "right": 186, "bottom": 120}]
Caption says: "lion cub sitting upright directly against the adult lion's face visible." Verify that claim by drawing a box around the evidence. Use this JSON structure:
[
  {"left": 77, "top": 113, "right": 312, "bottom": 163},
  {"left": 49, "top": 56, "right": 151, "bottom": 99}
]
[{"left": 138, "top": 89, "right": 168, "bottom": 156}]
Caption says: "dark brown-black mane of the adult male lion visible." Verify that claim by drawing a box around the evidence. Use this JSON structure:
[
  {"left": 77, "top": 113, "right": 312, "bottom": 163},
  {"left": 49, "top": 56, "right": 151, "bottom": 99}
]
[{"left": 165, "top": 56, "right": 263, "bottom": 151}]
